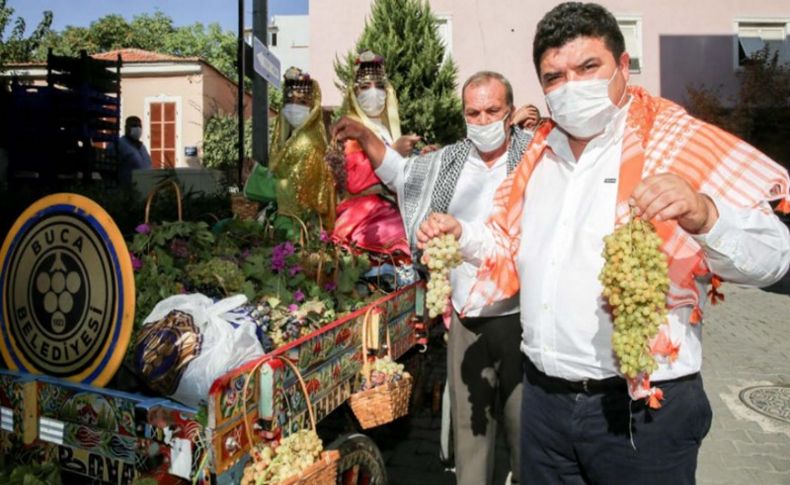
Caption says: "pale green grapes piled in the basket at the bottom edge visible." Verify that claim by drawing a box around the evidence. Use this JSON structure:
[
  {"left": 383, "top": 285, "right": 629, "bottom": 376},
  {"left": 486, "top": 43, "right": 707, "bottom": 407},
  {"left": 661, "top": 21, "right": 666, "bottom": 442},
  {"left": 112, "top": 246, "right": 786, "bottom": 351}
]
[{"left": 241, "top": 429, "right": 324, "bottom": 485}]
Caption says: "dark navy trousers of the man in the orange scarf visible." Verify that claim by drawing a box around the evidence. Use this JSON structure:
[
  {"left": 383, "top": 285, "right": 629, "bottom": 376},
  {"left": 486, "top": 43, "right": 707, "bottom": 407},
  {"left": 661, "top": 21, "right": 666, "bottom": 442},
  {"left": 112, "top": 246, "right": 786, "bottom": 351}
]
[{"left": 521, "top": 358, "right": 713, "bottom": 485}]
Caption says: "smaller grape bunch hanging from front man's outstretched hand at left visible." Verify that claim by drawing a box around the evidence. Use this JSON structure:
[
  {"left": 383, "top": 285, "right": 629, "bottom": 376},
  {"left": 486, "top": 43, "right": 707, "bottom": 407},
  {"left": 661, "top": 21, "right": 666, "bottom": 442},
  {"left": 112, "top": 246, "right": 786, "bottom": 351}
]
[{"left": 422, "top": 234, "right": 461, "bottom": 318}]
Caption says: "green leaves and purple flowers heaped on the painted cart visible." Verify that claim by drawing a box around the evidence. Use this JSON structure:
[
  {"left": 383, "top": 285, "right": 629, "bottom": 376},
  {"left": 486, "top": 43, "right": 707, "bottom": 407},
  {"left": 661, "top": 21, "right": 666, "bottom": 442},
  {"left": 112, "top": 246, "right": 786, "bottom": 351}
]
[{"left": 129, "top": 215, "right": 377, "bottom": 351}]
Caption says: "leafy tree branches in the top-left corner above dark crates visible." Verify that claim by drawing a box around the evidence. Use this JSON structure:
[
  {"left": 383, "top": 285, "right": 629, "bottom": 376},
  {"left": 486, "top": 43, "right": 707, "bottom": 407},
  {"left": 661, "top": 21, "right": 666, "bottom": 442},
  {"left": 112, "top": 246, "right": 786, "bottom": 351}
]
[{"left": 0, "top": 0, "right": 52, "bottom": 68}]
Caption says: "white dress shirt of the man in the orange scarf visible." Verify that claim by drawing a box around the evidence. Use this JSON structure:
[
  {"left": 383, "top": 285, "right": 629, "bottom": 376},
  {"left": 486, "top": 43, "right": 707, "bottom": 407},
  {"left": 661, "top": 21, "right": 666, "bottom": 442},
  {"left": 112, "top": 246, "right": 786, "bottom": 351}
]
[{"left": 460, "top": 106, "right": 790, "bottom": 381}]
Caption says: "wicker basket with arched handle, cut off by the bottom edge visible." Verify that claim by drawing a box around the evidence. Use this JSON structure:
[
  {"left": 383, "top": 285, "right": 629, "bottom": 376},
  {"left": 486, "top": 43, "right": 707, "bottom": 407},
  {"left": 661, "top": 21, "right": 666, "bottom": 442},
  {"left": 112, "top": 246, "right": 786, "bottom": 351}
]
[{"left": 242, "top": 355, "right": 340, "bottom": 485}]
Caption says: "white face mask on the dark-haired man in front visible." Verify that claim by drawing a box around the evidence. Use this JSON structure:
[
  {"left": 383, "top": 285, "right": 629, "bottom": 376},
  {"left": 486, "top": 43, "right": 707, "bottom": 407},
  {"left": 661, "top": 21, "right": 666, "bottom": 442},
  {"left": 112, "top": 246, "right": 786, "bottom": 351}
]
[{"left": 546, "top": 69, "right": 625, "bottom": 139}]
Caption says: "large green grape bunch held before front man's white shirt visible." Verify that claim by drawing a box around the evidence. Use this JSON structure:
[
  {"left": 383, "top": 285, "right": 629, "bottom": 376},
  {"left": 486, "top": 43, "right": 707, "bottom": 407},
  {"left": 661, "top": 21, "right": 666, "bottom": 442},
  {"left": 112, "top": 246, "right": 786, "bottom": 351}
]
[{"left": 599, "top": 217, "right": 669, "bottom": 379}]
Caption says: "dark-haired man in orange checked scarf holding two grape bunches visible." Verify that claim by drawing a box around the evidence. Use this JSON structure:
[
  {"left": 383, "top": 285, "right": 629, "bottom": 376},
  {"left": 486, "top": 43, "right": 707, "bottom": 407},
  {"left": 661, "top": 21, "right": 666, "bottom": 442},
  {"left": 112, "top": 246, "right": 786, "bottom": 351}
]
[{"left": 418, "top": 2, "right": 790, "bottom": 485}]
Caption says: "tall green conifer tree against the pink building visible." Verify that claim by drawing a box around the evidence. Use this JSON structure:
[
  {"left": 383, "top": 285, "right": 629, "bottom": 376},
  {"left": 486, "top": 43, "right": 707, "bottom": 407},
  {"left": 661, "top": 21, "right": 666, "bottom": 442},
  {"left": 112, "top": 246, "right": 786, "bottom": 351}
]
[{"left": 335, "top": 0, "right": 464, "bottom": 143}]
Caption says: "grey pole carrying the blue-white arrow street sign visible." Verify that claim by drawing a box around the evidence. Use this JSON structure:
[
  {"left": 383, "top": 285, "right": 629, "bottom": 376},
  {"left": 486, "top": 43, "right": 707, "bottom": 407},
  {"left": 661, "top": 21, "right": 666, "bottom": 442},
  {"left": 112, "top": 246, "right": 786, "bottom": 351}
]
[{"left": 252, "top": 0, "right": 269, "bottom": 166}]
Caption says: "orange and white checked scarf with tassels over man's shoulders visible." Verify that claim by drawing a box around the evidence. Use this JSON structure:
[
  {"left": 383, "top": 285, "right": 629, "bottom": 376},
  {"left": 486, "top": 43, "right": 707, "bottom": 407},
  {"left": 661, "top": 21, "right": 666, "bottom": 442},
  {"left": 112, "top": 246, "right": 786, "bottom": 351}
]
[{"left": 464, "top": 86, "right": 790, "bottom": 407}]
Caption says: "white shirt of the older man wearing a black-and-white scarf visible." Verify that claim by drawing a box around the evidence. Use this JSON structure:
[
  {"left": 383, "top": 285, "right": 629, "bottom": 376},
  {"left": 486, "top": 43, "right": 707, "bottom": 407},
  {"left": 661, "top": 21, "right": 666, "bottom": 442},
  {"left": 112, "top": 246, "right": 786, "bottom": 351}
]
[{"left": 376, "top": 147, "right": 518, "bottom": 317}]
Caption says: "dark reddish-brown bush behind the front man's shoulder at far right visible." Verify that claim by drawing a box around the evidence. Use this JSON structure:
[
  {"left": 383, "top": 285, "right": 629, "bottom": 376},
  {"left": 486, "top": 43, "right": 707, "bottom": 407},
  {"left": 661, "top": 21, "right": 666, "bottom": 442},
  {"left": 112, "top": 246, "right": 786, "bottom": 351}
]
[{"left": 687, "top": 46, "right": 790, "bottom": 167}]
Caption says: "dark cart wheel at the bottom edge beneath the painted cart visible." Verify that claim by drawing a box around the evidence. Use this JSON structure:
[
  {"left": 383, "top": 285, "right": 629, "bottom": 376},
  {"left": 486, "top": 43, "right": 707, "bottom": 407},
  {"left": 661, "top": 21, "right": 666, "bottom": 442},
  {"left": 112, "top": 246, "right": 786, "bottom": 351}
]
[{"left": 327, "top": 433, "right": 387, "bottom": 485}]
